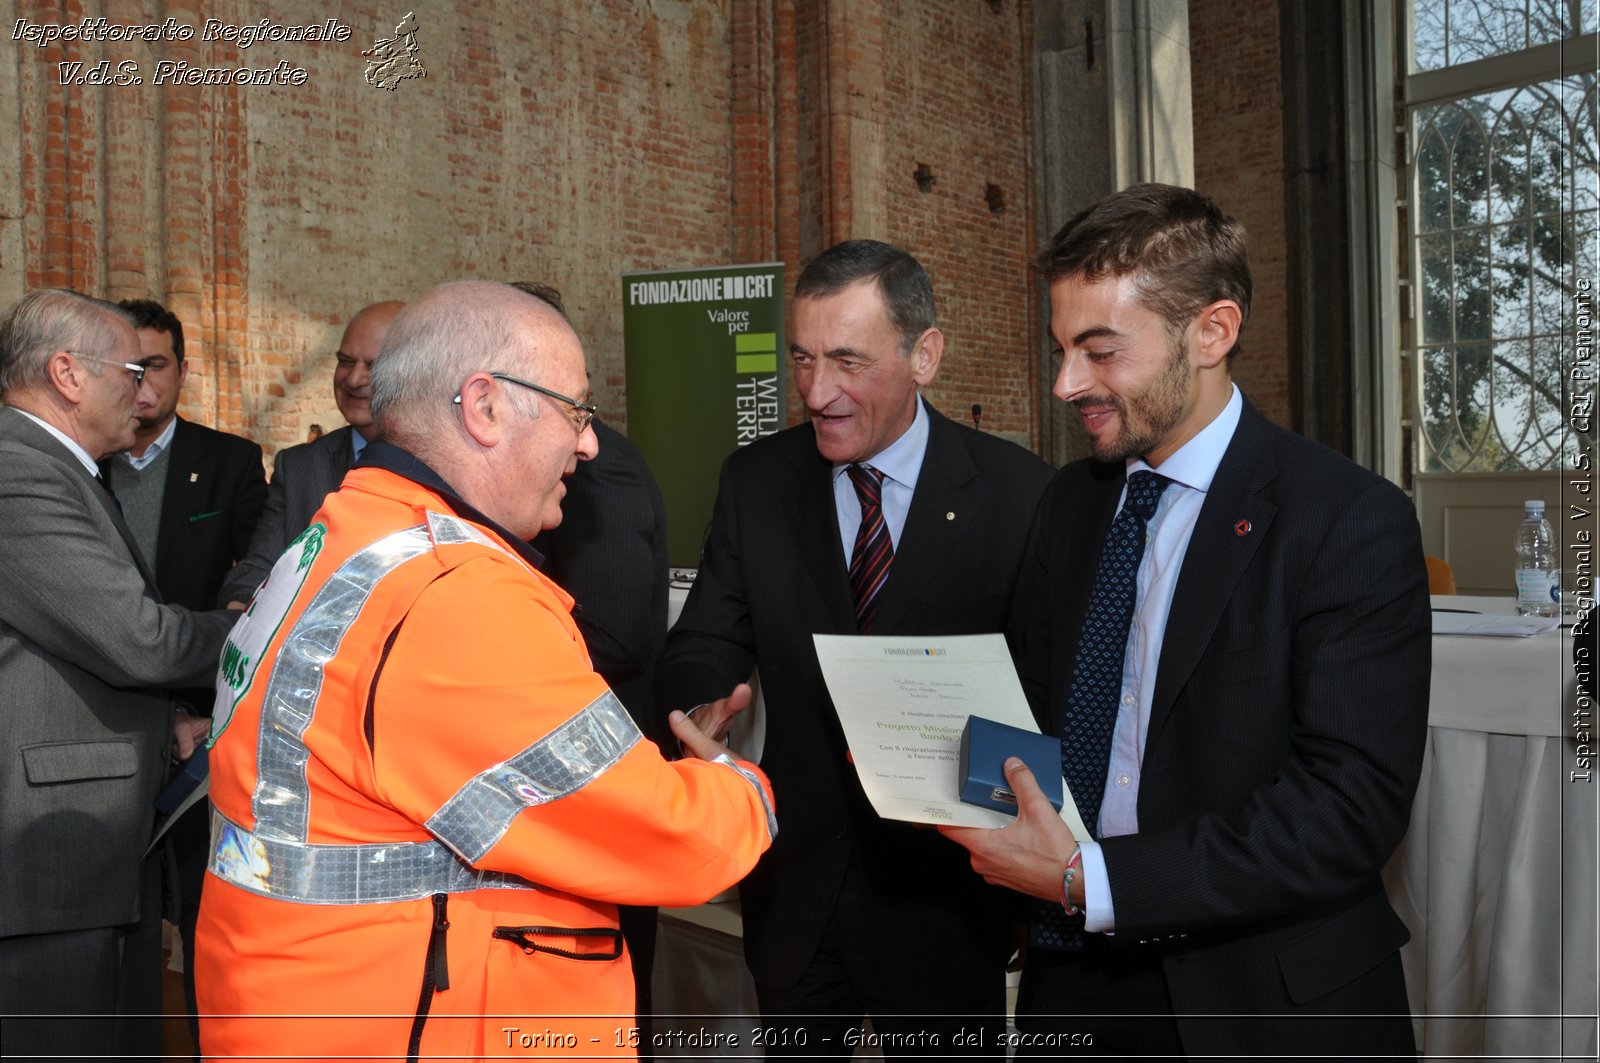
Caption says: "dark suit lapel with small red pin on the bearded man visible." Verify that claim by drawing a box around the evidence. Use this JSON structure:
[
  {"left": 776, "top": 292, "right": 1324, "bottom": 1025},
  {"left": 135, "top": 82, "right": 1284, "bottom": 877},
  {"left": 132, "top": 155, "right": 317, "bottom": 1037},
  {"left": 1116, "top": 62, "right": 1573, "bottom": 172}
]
[{"left": 1146, "top": 402, "right": 1277, "bottom": 749}]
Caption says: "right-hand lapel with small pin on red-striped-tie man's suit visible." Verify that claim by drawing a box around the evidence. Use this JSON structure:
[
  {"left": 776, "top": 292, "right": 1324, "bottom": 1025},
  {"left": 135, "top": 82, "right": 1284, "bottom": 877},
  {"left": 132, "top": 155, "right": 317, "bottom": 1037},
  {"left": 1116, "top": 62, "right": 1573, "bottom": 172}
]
[{"left": 876, "top": 407, "right": 978, "bottom": 634}]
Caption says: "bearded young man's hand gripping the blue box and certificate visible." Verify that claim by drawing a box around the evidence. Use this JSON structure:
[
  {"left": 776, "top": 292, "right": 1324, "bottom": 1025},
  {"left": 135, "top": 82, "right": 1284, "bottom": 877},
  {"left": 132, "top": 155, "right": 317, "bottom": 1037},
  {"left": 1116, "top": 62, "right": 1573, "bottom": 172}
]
[{"left": 939, "top": 757, "right": 1077, "bottom": 901}]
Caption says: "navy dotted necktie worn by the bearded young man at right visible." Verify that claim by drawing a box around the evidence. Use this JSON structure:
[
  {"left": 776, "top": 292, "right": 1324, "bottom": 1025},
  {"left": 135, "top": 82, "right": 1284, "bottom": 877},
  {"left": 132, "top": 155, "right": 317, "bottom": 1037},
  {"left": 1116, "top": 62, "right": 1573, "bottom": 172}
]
[{"left": 1029, "top": 469, "right": 1171, "bottom": 948}]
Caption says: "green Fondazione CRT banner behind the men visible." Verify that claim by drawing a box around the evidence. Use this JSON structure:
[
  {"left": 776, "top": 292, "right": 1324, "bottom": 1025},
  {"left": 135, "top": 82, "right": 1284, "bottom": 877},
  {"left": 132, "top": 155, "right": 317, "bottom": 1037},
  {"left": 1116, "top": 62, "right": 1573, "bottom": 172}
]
[{"left": 622, "top": 263, "right": 786, "bottom": 568}]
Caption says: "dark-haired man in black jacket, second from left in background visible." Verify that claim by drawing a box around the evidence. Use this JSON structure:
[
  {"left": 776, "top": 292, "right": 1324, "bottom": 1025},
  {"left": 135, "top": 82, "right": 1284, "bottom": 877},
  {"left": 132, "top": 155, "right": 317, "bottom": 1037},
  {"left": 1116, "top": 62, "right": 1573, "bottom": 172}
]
[{"left": 101, "top": 299, "right": 267, "bottom": 1037}]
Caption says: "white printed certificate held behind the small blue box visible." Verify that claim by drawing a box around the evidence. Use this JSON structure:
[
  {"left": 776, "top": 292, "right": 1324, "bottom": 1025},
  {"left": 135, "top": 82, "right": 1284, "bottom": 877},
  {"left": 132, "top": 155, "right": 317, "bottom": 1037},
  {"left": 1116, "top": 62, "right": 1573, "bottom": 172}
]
[{"left": 811, "top": 634, "right": 1088, "bottom": 837}]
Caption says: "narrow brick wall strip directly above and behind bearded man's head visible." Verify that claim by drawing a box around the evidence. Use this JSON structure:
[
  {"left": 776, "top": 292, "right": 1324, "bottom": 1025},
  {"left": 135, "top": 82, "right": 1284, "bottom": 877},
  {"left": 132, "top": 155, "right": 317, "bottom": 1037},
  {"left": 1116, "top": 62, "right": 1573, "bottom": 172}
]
[{"left": 1189, "top": 0, "right": 1290, "bottom": 426}]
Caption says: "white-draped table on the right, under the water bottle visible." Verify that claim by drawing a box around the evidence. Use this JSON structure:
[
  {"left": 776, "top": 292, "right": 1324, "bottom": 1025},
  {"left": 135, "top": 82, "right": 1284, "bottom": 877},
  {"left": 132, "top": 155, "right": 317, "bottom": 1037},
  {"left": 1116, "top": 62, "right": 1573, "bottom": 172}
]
[{"left": 1384, "top": 596, "right": 1600, "bottom": 1058}]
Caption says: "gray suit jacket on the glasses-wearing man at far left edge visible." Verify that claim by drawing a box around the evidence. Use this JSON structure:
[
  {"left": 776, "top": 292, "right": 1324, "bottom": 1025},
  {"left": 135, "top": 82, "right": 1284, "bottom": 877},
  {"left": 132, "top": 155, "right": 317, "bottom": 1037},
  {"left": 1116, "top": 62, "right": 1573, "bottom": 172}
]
[{"left": 0, "top": 408, "right": 234, "bottom": 937}]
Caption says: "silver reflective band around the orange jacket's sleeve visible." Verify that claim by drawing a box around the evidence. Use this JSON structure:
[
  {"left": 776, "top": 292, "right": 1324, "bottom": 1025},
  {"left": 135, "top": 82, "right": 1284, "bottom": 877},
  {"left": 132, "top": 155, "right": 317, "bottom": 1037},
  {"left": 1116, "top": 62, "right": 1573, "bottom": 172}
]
[{"left": 427, "top": 690, "right": 643, "bottom": 861}]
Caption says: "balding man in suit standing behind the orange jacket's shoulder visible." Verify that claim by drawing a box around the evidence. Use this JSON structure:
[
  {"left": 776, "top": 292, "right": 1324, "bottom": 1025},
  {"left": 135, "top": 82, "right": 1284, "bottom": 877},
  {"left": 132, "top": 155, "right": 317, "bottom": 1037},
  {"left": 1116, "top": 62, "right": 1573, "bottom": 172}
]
[{"left": 218, "top": 301, "right": 405, "bottom": 605}]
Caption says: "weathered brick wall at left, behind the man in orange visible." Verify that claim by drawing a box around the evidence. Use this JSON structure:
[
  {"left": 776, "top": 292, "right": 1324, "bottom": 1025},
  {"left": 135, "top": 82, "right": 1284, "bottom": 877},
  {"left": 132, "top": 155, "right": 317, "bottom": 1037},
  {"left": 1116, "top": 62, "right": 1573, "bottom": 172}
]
[{"left": 0, "top": 0, "right": 742, "bottom": 453}]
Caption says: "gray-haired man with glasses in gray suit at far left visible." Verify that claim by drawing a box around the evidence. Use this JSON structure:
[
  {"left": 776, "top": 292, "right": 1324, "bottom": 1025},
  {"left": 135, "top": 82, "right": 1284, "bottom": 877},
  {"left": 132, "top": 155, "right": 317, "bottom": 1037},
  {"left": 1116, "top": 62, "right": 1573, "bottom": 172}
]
[{"left": 0, "top": 290, "right": 232, "bottom": 1055}]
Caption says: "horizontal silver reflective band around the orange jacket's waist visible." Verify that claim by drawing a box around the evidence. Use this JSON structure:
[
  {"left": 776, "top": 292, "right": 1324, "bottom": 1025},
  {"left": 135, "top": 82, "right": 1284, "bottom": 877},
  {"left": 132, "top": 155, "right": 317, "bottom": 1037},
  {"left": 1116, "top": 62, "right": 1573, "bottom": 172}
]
[{"left": 210, "top": 808, "right": 539, "bottom": 905}]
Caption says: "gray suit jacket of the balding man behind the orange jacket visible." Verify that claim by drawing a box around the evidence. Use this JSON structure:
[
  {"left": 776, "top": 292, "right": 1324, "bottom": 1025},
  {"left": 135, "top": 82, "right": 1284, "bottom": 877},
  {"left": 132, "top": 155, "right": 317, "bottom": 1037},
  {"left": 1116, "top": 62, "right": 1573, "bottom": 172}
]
[{"left": 216, "top": 424, "right": 355, "bottom": 605}]
